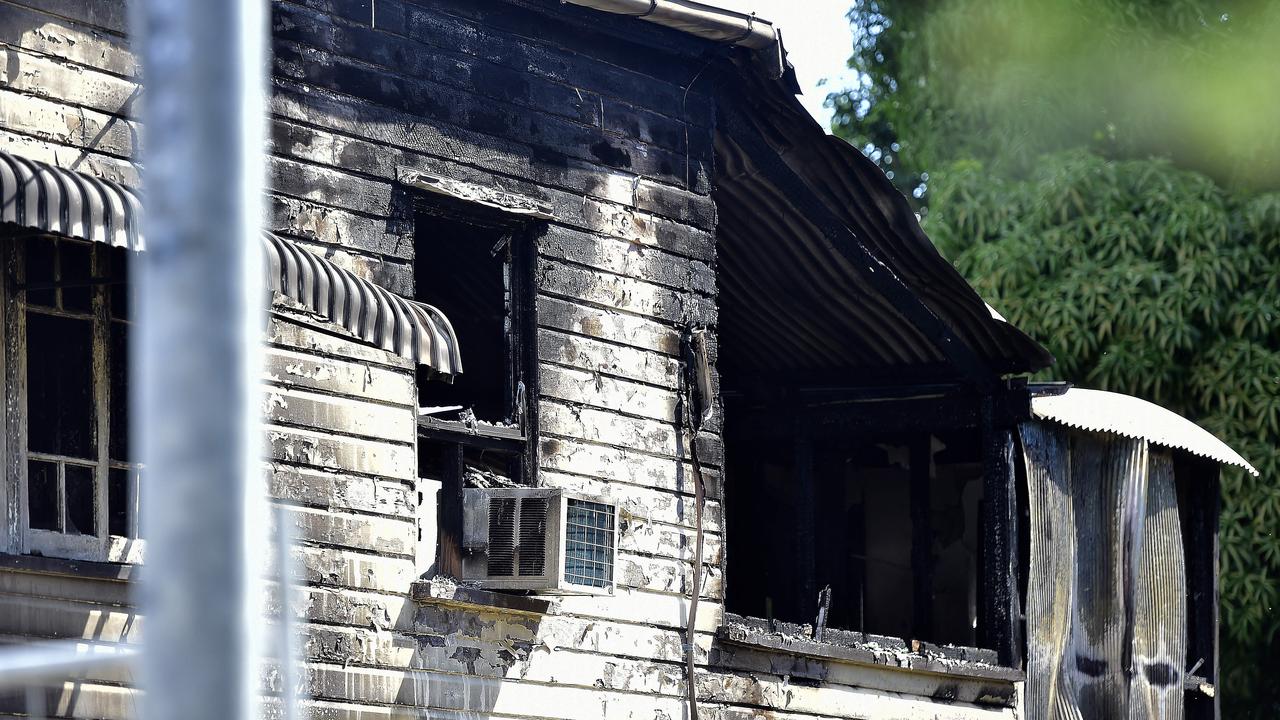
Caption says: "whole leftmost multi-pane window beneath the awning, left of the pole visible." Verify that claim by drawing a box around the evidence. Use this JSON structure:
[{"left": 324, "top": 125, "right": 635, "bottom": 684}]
[{"left": 4, "top": 233, "right": 141, "bottom": 561}]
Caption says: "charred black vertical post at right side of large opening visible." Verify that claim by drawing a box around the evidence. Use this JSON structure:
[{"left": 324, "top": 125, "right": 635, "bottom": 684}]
[{"left": 978, "top": 400, "right": 1023, "bottom": 667}]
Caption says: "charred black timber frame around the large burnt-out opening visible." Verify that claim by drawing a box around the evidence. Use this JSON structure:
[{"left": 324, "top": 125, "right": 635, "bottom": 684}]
[{"left": 721, "top": 379, "right": 1030, "bottom": 679}]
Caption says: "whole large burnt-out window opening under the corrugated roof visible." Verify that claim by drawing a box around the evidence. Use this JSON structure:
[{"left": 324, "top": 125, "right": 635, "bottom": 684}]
[{"left": 721, "top": 371, "right": 1016, "bottom": 662}]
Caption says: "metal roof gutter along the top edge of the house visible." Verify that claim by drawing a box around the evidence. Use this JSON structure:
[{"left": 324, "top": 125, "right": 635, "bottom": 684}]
[{"left": 561, "top": 0, "right": 786, "bottom": 77}]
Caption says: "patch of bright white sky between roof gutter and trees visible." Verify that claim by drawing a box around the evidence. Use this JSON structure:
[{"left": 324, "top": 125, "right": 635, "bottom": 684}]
[{"left": 710, "top": 0, "right": 854, "bottom": 128}]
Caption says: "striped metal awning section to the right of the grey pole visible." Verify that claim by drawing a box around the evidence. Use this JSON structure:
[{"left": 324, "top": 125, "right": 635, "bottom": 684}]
[{"left": 262, "top": 233, "right": 462, "bottom": 375}]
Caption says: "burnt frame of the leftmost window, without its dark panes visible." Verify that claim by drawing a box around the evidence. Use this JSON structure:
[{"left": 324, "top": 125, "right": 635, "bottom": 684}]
[{"left": 0, "top": 225, "right": 146, "bottom": 564}]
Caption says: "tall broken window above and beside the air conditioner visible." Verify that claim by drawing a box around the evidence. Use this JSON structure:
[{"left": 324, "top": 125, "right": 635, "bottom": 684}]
[{"left": 413, "top": 206, "right": 535, "bottom": 577}]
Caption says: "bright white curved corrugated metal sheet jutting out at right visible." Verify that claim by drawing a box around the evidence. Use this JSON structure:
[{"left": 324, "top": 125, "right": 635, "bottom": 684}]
[{"left": 1032, "top": 388, "right": 1258, "bottom": 475}]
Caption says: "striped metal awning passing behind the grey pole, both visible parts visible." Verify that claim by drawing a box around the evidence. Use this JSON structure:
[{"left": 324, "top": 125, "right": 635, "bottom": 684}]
[{"left": 0, "top": 151, "right": 462, "bottom": 375}]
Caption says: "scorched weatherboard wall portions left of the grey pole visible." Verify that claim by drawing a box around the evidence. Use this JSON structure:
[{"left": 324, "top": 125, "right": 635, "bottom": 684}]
[{"left": 0, "top": 0, "right": 145, "bottom": 717}]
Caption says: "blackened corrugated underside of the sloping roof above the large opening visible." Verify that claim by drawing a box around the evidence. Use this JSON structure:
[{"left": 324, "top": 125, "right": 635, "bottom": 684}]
[{"left": 713, "top": 62, "right": 1052, "bottom": 373}]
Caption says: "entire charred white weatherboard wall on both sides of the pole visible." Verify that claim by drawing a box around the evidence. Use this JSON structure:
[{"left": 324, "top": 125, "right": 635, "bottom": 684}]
[{"left": 0, "top": 0, "right": 1012, "bottom": 720}]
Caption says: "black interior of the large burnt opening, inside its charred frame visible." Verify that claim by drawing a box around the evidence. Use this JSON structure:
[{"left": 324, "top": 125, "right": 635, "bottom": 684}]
[{"left": 726, "top": 412, "right": 983, "bottom": 647}]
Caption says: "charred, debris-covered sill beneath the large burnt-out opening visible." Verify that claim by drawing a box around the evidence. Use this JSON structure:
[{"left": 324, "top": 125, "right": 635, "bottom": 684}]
[{"left": 716, "top": 614, "right": 1027, "bottom": 681}]
